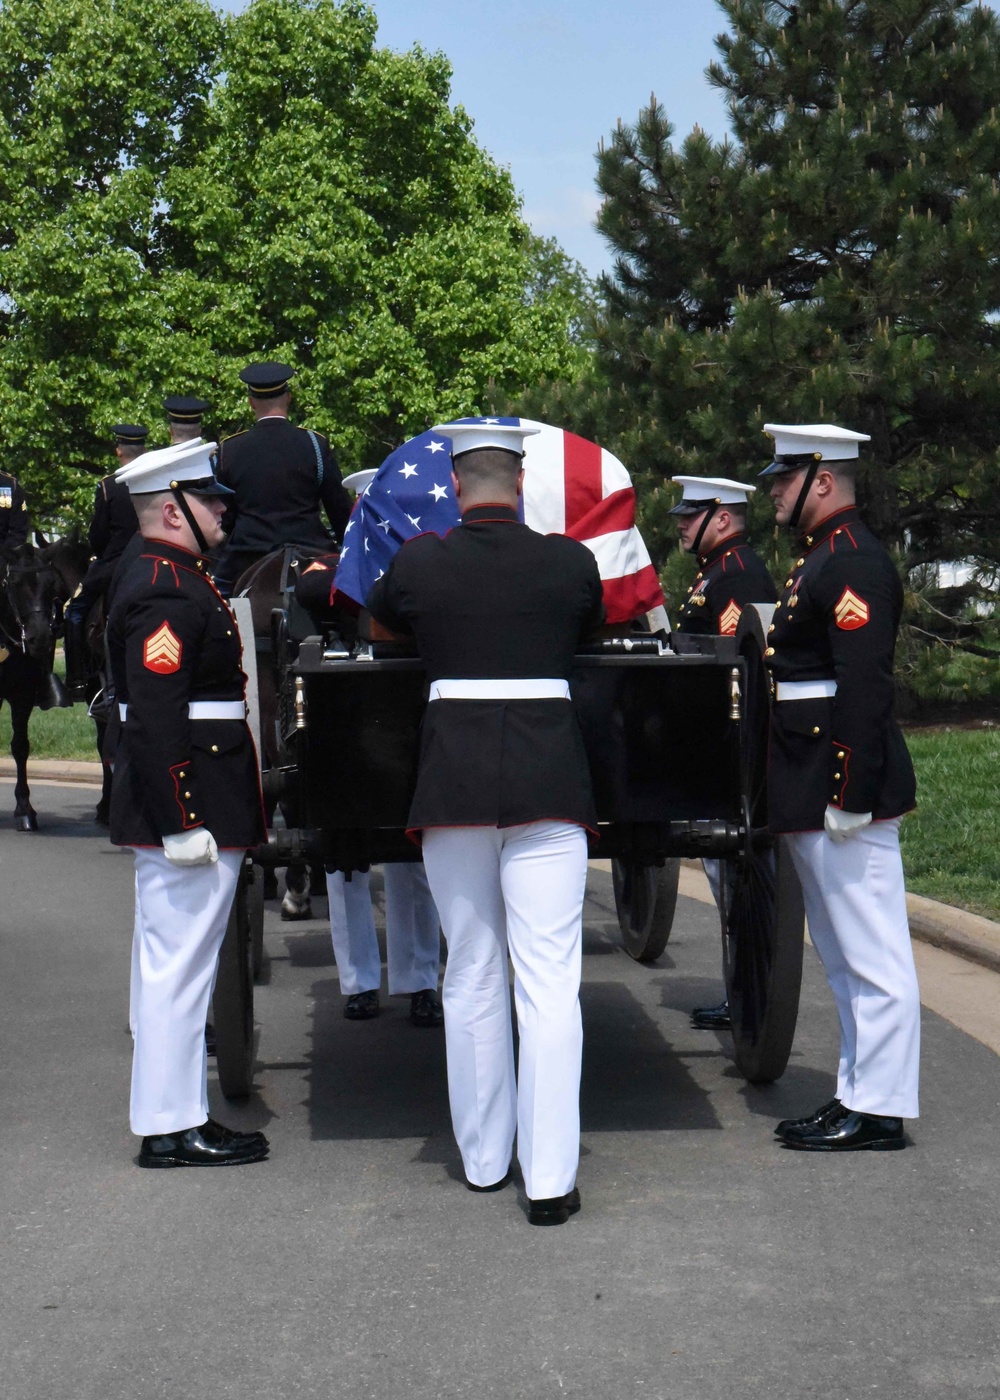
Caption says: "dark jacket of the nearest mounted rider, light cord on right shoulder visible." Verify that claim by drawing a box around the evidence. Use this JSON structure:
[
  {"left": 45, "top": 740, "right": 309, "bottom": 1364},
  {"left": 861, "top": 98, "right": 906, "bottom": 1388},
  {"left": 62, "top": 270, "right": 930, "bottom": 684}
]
[{"left": 216, "top": 417, "right": 352, "bottom": 554}]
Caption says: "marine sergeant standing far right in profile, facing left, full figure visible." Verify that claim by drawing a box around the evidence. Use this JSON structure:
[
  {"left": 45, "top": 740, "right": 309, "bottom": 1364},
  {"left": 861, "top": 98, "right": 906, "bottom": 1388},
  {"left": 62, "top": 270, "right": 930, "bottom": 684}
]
[{"left": 761, "top": 424, "right": 920, "bottom": 1151}]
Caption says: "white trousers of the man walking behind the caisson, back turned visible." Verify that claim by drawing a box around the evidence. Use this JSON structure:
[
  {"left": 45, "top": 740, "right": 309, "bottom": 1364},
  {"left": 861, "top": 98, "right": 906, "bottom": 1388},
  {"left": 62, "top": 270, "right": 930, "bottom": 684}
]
[{"left": 423, "top": 822, "right": 587, "bottom": 1200}]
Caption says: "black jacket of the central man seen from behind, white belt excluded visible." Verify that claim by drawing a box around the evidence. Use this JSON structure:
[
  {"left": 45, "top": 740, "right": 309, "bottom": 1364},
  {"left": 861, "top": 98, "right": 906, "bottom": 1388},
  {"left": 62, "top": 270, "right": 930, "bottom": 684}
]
[{"left": 367, "top": 505, "right": 604, "bottom": 830}]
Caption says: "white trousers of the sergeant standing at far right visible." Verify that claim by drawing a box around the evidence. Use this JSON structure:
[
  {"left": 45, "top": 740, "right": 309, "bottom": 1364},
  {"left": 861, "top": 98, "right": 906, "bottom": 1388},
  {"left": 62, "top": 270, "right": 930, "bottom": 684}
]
[{"left": 784, "top": 819, "right": 920, "bottom": 1119}]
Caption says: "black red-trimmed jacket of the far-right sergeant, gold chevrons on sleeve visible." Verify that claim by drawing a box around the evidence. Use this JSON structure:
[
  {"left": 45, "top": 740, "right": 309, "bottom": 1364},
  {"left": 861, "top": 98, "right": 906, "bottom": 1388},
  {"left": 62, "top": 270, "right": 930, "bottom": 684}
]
[{"left": 765, "top": 505, "right": 916, "bottom": 832}]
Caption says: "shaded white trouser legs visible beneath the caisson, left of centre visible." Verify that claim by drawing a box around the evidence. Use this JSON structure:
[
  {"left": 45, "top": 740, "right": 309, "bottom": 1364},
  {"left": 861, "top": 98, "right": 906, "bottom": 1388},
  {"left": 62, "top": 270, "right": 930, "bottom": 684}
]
[{"left": 326, "top": 861, "right": 441, "bottom": 997}]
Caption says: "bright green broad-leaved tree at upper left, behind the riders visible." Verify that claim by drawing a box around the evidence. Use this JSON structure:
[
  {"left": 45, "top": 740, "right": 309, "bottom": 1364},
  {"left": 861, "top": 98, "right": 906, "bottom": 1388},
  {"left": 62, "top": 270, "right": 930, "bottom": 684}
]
[{"left": 0, "top": 0, "right": 581, "bottom": 517}]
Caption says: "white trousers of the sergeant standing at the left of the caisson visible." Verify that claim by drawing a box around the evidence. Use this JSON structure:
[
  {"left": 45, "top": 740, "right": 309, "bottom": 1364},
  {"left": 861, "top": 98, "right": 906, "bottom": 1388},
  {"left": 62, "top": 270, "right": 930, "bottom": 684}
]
[{"left": 130, "top": 848, "right": 244, "bottom": 1137}]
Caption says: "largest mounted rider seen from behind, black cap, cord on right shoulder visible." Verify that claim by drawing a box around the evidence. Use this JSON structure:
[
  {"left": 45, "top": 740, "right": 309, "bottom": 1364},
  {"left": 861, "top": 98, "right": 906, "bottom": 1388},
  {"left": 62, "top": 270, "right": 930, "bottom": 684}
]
[{"left": 216, "top": 361, "right": 352, "bottom": 592}]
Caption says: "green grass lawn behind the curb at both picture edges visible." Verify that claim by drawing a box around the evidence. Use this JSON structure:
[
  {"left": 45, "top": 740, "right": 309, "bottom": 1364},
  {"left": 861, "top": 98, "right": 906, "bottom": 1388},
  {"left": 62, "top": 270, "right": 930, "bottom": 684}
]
[{"left": 0, "top": 688, "right": 1000, "bottom": 918}]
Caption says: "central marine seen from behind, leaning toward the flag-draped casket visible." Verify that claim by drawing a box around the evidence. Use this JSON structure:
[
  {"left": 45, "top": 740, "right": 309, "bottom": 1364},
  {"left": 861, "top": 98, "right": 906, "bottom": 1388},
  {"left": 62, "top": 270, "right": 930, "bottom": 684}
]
[{"left": 368, "top": 424, "right": 604, "bottom": 1225}]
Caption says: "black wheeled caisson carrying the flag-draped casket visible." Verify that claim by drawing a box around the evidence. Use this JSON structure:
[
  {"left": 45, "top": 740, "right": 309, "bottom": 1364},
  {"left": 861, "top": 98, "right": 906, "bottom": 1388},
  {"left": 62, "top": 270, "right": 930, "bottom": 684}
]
[{"left": 216, "top": 596, "right": 803, "bottom": 1093}]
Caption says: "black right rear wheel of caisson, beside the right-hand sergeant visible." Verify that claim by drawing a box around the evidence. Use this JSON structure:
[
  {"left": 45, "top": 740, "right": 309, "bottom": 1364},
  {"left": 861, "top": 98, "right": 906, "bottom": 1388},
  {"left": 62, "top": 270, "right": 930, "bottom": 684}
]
[{"left": 721, "top": 606, "right": 804, "bottom": 1084}]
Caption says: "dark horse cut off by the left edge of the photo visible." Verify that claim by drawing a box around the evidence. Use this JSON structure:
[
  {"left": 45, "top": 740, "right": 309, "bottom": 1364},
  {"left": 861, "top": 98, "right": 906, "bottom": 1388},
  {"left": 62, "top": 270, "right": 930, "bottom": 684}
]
[{"left": 0, "top": 535, "right": 86, "bottom": 832}]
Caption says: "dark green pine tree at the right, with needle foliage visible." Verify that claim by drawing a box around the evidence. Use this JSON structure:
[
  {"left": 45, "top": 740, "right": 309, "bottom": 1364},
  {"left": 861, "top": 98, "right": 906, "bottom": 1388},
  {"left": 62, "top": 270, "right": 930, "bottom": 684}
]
[{"left": 535, "top": 0, "right": 1000, "bottom": 635}]
